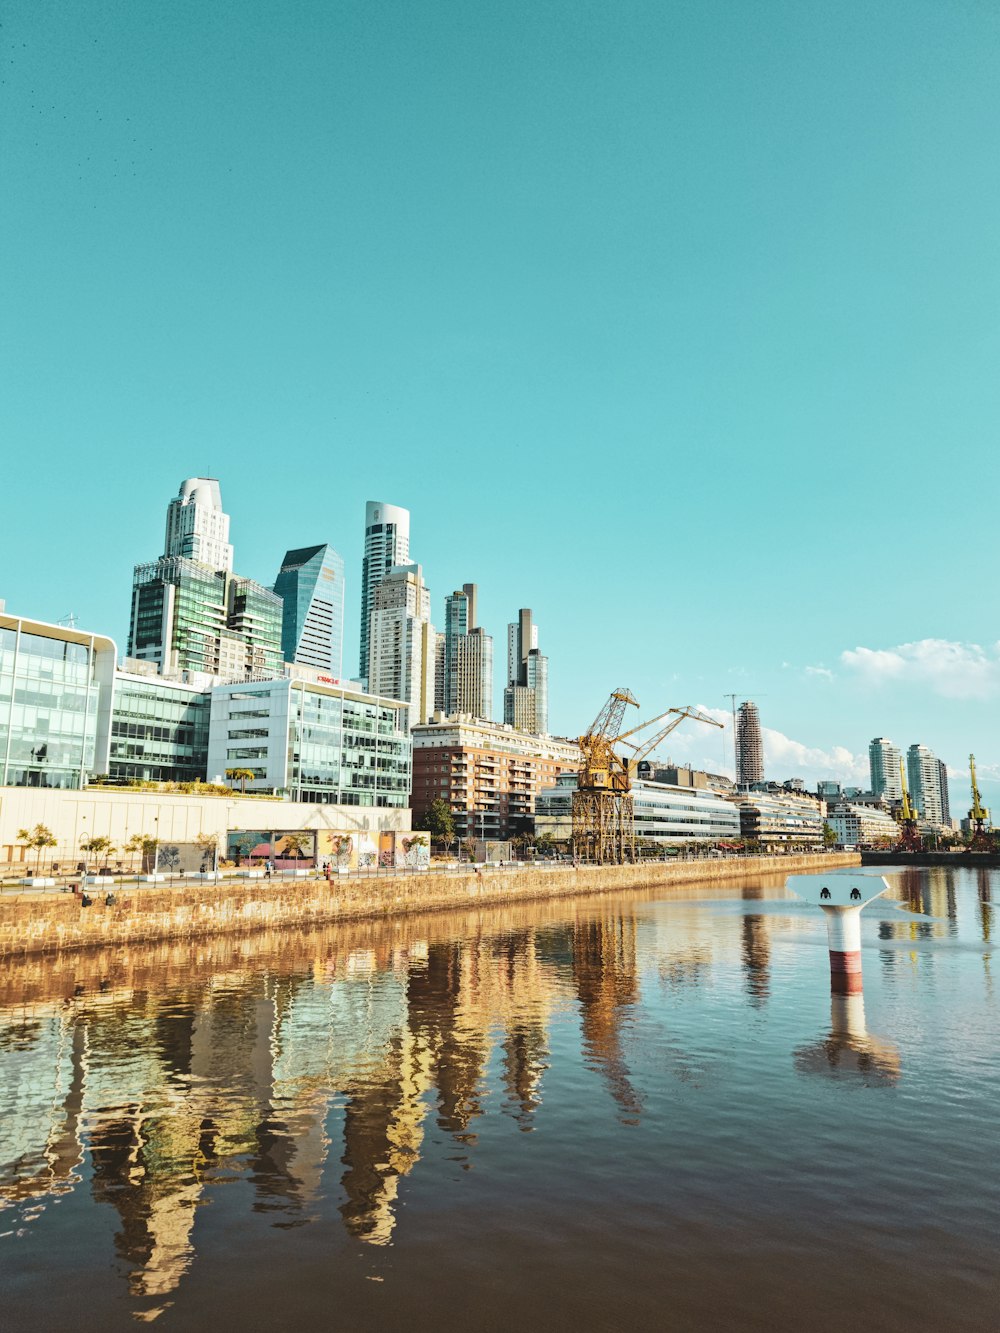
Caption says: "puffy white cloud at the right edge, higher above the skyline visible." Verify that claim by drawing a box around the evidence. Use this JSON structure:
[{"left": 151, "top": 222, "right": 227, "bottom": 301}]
[{"left": 840, "top": 639, "right": 1000, "bottom": 698}]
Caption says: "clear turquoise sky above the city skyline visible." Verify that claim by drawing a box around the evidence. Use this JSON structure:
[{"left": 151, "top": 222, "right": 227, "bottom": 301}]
[{"left": 0, "top": 0, "right": 1000, "bottom": 799}]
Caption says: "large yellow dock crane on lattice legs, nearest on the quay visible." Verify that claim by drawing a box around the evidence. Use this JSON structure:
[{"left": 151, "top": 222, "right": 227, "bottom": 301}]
[{"left": 573, "top": 688, "right": 723, "bottom": 865}]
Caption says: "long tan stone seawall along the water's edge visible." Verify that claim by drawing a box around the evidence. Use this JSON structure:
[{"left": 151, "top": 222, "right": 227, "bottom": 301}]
[{"left": 0, "top": 853, "right": 859, "bottom": 957}]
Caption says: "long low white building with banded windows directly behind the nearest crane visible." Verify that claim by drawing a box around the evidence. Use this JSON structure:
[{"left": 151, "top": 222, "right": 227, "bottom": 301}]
[{"left": 535, "top": 773, "right": 740, "bottom": 842}]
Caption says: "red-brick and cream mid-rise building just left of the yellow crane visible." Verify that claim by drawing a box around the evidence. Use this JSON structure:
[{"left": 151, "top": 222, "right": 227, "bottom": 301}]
[{"left": 412, "top": 716, "right": 580, "bottom": 838}]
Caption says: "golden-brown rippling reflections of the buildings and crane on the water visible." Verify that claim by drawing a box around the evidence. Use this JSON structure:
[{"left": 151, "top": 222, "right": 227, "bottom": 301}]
[{"left": 0, "top": 914, "right": 650, "bottom": 1320}]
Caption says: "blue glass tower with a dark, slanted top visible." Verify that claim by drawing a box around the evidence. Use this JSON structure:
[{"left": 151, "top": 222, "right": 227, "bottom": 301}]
[{"left": 275, "top": 545, "right": 344, "bottom": 680}]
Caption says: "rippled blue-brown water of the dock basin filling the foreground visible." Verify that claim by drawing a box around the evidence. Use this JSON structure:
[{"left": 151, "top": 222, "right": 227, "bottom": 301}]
[{"left": 0, "top": 869, "right": 1000, "bottom": 1330}]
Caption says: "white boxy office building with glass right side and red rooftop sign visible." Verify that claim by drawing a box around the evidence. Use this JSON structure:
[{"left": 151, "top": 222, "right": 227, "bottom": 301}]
[{"left": 208, "top": 668, "right": 411, "bottom": 809}]
